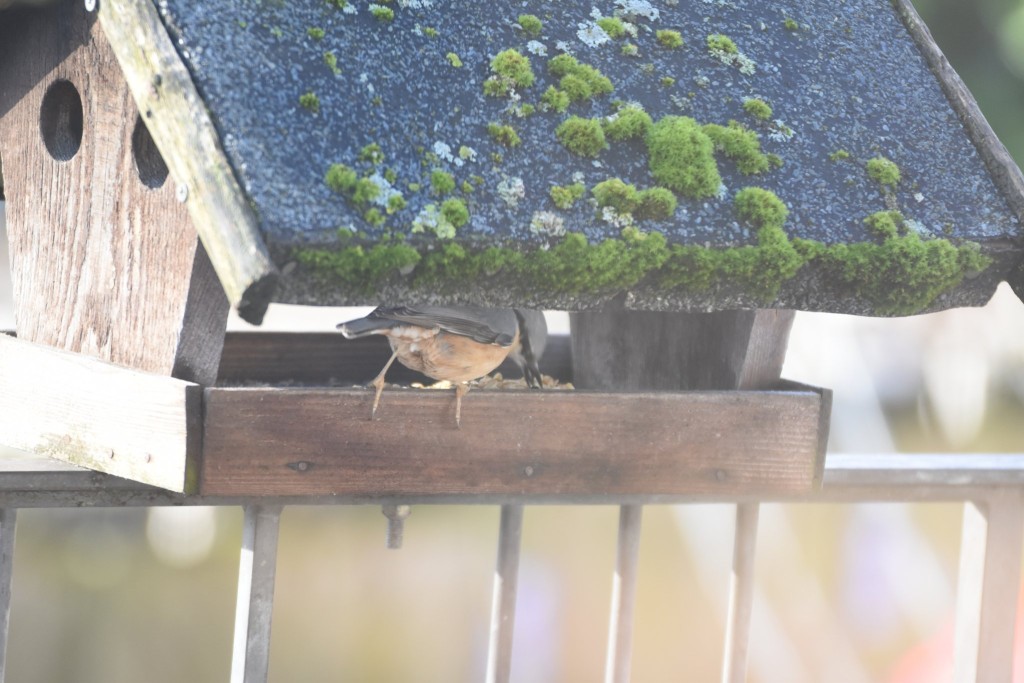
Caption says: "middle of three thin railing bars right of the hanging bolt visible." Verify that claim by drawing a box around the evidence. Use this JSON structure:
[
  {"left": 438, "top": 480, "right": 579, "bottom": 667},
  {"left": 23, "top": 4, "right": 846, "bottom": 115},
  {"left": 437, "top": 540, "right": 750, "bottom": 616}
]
[{"left": 604, "top": 505, "right": 643, "bottom": 683}]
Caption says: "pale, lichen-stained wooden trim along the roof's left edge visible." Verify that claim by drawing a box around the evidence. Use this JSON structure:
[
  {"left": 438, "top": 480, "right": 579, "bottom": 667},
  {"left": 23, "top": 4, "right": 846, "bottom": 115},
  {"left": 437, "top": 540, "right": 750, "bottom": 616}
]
[{"left": 99, "top": 0, "right": 280, "bottom": 325}]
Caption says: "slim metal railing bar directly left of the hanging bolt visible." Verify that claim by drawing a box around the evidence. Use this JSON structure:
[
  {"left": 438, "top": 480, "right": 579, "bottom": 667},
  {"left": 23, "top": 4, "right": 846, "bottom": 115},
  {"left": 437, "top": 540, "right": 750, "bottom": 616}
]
[{"left": 230, "top": 505, "right": 282, "bottom": 683}]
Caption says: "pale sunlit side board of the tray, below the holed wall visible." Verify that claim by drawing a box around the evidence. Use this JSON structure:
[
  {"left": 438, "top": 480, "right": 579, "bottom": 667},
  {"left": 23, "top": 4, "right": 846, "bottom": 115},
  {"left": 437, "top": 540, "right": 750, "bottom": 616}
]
[{"left": 0, "top": 335, "right": 202, "bottom": 492}]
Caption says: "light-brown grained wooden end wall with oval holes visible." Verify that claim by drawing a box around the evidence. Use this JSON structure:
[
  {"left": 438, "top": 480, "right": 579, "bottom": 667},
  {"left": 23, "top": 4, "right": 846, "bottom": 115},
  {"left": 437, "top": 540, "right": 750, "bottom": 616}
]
[{"left": 0, "top": 2, "right": 227, "bottom": 383}]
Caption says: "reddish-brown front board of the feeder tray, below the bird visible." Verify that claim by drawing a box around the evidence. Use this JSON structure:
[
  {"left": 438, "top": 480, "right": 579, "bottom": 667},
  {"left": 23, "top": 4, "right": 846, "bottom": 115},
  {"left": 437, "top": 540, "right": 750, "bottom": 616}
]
[{"left": 201, "top": 388, "right": 824, "bottom": 503}]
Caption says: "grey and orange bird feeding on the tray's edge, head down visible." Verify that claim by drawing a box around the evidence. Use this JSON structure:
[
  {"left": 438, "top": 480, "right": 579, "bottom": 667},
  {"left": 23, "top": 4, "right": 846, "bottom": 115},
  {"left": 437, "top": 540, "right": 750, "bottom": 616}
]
[{"left": 338, "top": 306, "right": 548, "bottom": 427}]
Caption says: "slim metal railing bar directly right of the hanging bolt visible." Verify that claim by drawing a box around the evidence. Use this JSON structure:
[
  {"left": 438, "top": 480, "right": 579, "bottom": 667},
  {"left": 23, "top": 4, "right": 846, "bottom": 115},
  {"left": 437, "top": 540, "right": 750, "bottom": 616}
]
[{"left": 484, "top": 505, "right": 522, "bottom": 683}]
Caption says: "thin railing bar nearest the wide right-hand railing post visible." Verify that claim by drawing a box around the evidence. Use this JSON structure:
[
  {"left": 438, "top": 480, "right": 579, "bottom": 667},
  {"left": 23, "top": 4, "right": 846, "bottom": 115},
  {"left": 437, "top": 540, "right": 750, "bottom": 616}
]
[{"left": 722, "top": 503, "right": 761, "bottom": 683}]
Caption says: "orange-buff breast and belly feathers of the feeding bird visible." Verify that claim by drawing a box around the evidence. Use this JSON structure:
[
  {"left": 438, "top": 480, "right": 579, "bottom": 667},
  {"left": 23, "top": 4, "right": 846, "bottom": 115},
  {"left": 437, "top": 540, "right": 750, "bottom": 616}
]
[{"left": 386, "top": 325, "right": 519, "bottom": 382}]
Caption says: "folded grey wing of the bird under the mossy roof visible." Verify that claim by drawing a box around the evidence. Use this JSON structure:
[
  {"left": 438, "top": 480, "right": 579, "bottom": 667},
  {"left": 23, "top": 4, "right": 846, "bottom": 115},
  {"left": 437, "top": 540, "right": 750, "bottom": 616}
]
[{"left": 370, "top": 306, "right": 518, "bottom": 346}]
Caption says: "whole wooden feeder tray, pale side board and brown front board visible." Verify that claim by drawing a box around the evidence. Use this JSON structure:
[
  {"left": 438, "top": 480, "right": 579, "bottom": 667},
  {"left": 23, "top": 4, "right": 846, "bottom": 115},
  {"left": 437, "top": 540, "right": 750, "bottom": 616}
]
[{"left": 0, "top": 334, "right": 830, "bottom": 503}]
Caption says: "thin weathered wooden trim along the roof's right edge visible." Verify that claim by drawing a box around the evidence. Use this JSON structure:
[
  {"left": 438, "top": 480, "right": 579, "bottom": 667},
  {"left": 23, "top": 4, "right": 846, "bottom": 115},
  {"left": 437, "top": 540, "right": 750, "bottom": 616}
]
[{"left": 893, "top": 0, "right": 1024, "bottom": 222}]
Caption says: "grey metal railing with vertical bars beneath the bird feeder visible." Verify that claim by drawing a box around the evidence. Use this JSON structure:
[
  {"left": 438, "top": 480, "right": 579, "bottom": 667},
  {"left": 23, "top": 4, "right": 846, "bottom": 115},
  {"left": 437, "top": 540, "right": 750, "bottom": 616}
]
[{"left": 0, "top": 455, "right": 1024, "bottom": 683}]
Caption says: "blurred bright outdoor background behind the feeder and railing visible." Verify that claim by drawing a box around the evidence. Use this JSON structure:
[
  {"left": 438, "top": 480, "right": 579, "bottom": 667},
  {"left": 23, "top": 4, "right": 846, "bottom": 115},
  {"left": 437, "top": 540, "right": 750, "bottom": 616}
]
[{"left": 0, "top": 0, "right": 1024, "bottom": 683}]
